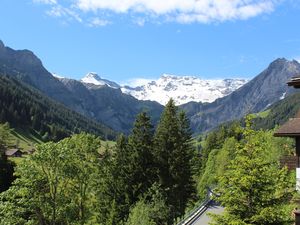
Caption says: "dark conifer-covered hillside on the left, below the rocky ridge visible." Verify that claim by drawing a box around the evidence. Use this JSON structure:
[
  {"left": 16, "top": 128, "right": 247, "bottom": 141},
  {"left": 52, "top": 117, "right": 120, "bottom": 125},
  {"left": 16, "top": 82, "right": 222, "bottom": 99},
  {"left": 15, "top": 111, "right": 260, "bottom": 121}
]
[{"left": 0, "top": 75, "right": 116, "bottom": 141}]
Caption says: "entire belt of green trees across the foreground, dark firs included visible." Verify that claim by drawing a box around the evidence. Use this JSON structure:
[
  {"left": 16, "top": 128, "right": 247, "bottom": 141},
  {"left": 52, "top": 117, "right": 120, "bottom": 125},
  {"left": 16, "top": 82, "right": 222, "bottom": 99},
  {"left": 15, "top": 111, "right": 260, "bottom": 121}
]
[{"left": 0, "top": 99, "right": 299, "bottom": 225}]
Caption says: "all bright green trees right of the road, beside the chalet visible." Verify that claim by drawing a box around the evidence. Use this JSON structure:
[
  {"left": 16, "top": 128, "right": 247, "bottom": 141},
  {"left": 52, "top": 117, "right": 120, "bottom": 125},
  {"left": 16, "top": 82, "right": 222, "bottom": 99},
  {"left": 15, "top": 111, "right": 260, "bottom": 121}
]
[{"left": 197, "top": 116, "right": 298, "bottom": 225}]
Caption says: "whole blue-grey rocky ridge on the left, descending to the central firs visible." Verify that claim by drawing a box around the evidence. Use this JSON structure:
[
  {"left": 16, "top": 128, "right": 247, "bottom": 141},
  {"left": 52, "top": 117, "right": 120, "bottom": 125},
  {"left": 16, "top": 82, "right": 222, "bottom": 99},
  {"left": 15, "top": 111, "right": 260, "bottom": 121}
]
[{"left": 0, "top": 41, "right": 163, "bottom": 133}]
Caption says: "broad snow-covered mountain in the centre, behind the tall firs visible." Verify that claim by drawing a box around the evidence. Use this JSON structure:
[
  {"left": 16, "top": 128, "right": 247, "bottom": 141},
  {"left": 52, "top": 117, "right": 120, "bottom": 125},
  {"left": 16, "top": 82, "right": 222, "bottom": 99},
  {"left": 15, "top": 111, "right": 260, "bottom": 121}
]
[{"left": 121, "top": 74, "right": 247, "bottom": 105}]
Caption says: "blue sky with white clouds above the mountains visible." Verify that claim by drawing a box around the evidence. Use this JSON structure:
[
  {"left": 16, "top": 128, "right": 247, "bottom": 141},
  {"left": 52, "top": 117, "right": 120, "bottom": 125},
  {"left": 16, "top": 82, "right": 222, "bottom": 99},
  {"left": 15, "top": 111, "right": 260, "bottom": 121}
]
[{"left": 0, "top": 0, "right": 300, "bottom": 83}]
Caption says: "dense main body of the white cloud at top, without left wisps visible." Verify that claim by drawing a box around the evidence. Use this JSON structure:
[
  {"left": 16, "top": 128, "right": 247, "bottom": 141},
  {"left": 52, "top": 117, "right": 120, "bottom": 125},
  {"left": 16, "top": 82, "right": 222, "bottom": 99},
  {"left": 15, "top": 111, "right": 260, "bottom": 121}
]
[{"left": 75, "top": 0, "right": 277, "bottom": 23}]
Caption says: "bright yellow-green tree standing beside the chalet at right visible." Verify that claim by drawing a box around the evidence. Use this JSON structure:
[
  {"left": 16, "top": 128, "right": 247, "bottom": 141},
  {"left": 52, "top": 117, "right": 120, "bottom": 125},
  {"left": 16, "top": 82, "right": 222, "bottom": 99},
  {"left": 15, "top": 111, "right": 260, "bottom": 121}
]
[{"left": 210, "top": 119, "right": 293, "bottom": 225}]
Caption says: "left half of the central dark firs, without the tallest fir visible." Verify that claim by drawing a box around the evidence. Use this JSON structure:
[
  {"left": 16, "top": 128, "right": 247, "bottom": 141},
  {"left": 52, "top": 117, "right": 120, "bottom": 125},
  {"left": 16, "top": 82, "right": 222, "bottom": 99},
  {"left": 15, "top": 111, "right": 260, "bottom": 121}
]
[{"left": 98, "top": 112, "right": 155, "bottom": 224}]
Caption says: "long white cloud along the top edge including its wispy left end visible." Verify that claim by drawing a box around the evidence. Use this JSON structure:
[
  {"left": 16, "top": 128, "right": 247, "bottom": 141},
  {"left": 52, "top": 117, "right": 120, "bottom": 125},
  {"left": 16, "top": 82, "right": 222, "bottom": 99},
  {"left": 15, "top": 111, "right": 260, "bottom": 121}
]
[{"left": 33, "top": 0, "right": 282, "bottom": 26}]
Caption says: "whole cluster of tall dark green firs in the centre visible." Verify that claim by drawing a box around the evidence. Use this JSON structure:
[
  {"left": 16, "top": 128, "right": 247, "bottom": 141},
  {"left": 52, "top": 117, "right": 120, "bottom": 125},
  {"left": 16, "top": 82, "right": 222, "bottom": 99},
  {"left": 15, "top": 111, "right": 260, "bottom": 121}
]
[{"left": 97, "top": 103, "right": 194, "bottom": 224}]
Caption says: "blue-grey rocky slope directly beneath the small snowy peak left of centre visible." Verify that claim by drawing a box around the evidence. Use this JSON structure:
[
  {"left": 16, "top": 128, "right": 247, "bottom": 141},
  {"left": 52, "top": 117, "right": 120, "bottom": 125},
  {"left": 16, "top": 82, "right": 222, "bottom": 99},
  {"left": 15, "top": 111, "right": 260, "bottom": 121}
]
[{"left": 60, "top": 78, "right": 163, "bottom": 133}]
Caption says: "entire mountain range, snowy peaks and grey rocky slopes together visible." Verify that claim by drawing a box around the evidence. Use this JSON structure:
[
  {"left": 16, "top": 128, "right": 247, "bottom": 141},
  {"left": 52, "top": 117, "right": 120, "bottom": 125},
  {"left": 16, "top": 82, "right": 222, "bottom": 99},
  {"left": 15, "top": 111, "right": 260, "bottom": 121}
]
[{"left": 0, "top": 41, "right": 300, "bottom": 134}]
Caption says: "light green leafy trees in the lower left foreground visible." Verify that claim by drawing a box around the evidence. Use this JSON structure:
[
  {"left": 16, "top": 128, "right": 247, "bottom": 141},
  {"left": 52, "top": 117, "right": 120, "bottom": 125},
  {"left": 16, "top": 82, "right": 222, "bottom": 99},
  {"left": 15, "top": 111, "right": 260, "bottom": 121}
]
[{"left": 0, "top": 134, "right": 100, "bottom": 224}]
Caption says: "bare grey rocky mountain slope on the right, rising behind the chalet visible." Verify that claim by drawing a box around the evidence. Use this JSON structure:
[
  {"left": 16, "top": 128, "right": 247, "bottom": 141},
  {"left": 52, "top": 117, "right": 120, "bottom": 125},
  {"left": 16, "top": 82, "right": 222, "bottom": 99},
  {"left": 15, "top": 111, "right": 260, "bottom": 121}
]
[{"left": 181, "top": 59, "right": 300, "bottom": 133}]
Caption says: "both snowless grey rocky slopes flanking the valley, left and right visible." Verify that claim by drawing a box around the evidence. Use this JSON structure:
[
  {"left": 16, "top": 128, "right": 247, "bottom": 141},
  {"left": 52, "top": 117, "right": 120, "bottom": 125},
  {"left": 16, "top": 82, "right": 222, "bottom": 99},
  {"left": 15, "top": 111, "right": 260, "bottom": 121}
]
[{"left": 0, "top": 39, "right": 300, "bottom": 134}]
